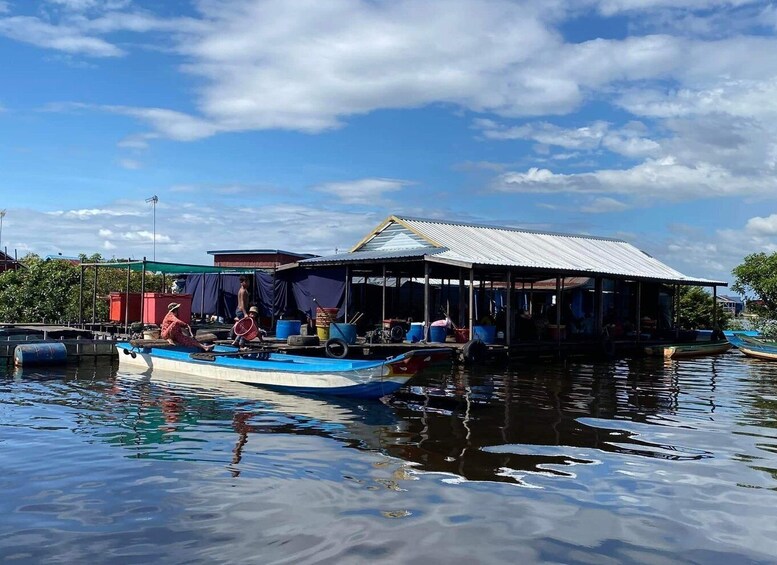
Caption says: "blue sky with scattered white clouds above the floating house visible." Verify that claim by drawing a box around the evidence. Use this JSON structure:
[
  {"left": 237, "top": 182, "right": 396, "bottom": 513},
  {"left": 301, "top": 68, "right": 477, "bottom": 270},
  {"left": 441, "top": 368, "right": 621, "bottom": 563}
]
[{"left": 0, "top": 0, "right": 777, "bottom": 281}]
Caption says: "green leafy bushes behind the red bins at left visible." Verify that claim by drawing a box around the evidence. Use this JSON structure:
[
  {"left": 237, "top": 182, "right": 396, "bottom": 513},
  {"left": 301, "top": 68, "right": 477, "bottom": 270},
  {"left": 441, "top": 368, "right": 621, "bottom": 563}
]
[{"left": 0, "top": 254, "right": 162, "bottom": 324}]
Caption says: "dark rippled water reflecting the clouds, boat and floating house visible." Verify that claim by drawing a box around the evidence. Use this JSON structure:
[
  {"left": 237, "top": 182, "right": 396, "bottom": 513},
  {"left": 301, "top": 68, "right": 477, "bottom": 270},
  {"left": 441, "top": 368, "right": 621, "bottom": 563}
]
[{"left": 0, "top": 352, "right": 777, "bottom": 564}]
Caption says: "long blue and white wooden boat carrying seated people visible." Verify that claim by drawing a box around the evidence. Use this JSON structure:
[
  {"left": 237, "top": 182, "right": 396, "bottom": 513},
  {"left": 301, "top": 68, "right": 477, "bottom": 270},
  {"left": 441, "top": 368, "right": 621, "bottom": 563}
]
[{"left": 116, "top": 340, "right": 450, "bottom": 398}]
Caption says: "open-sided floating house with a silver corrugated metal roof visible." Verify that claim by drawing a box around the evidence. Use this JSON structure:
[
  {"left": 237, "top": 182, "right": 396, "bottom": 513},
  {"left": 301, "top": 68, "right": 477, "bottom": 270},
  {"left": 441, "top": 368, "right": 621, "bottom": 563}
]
[{"left": 286, "top": 216, "right": 726, "bottom": 344}]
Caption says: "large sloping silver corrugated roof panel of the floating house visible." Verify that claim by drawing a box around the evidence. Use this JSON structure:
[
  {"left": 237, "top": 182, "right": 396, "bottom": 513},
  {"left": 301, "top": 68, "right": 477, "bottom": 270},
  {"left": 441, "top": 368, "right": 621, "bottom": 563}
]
[{"left": 376, "top": 217, "right": 726, "bottom": 285}]
